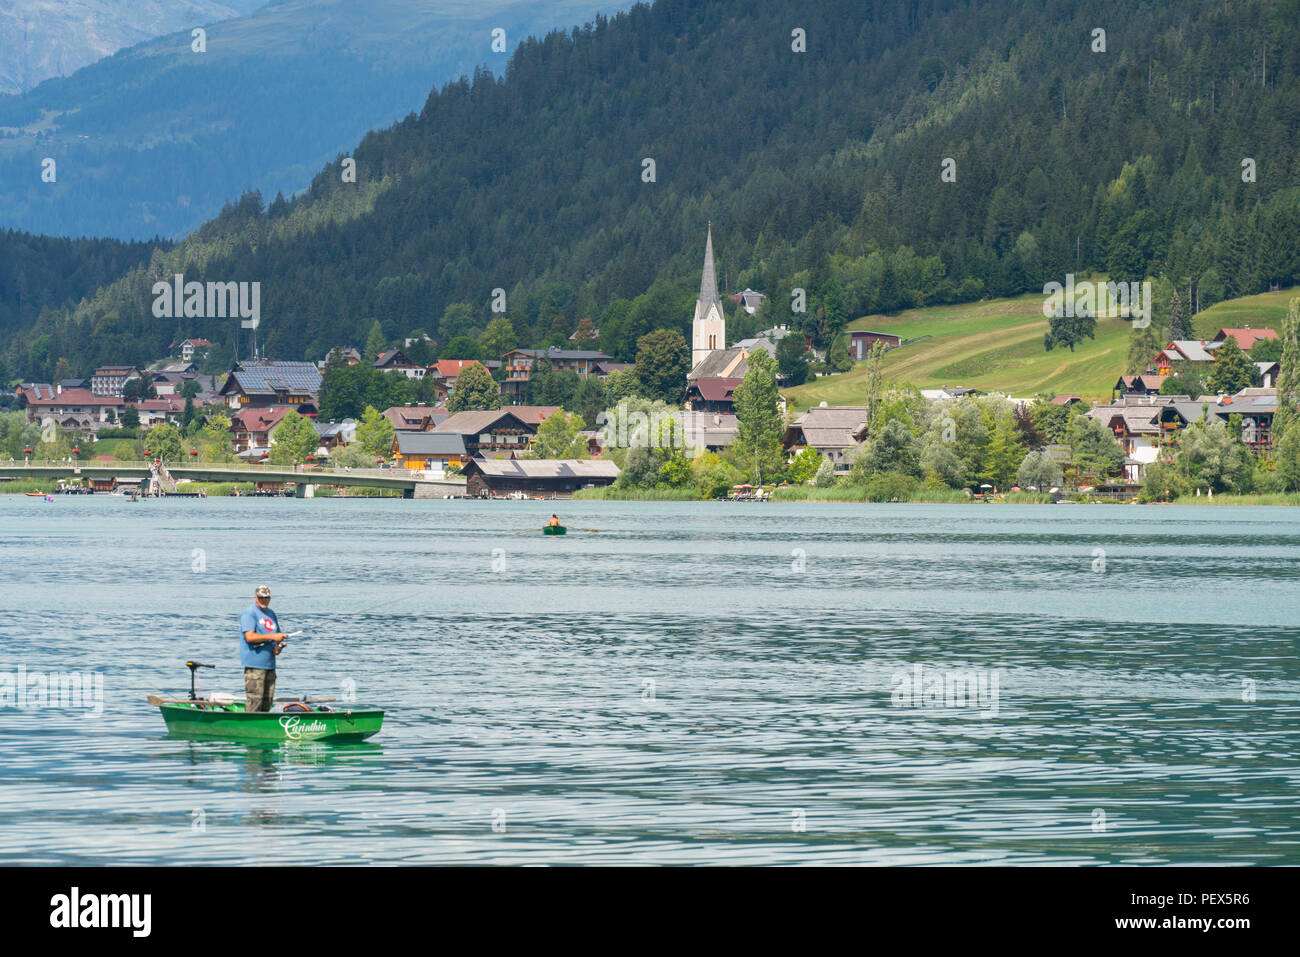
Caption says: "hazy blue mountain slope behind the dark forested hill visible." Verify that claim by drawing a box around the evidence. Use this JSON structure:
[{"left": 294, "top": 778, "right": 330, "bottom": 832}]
[{"left": 0, "top": 0, "right": 628, "bottom": 238}]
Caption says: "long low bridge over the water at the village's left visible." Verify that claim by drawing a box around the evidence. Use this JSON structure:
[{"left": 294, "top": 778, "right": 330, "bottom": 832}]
[{"left": 0, "top": 462, "right": 465, "bottom": 498}]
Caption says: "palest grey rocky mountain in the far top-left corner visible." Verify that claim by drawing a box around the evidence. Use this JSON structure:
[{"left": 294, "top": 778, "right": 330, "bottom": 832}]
[{"left": 0, "top": 0, "right": 267, "bottom": 94}]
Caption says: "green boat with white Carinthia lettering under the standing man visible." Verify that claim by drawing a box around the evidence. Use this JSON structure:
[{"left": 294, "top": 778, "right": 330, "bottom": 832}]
[{"left": 159, "top": 700, "right": 384, "bottom": 741}]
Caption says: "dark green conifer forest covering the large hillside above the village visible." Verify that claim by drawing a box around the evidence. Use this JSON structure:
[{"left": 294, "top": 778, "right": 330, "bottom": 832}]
[{"left": 0, "top": 0, "right": 1300, "bottom": 378}]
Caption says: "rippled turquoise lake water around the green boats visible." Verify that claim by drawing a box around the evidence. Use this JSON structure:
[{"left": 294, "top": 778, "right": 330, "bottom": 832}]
[{"left": 0, "top": 495, "right": 1300, "bottom": 865}]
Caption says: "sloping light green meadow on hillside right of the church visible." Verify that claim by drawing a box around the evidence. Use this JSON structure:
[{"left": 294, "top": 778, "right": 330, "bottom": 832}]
[{"left": 783, "top": 280, "right": 1300, "bottom": 410}]
